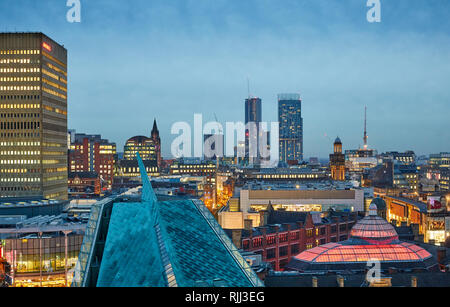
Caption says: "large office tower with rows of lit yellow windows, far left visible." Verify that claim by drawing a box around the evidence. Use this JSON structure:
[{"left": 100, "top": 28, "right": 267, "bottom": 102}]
[{"left": 0, "top": 33, "right": 68, "bottom": 199}]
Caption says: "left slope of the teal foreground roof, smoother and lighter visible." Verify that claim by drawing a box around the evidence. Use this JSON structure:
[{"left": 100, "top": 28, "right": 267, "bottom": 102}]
[{"left": 97, "top": 203, "right": 166, "bottom": 287}]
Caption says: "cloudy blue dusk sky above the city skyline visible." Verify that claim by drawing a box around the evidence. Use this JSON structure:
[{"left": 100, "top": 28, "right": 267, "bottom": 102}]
[{"left": 0, "top": 0, "right": 450, "bottom": 158}]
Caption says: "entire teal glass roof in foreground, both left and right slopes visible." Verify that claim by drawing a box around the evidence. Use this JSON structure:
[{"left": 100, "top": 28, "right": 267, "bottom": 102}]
[{"left": 97, "top": 200, "right": 253, "bottom": 287}]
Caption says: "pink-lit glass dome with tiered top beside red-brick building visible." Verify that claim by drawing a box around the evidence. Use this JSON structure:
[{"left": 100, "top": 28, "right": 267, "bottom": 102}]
[{"left": 287, "top": 203, "right": 436, "bottom": 272}]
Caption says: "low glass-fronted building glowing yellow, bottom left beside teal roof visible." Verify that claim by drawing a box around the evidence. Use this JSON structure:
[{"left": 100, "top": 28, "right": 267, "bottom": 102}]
[{"left": 0, "top": 215, "right": 86, "bottom": 287}]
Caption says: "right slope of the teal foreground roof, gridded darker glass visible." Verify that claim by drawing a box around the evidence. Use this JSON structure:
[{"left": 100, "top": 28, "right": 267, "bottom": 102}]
[{"left": 160, "top": 200, "right": 252, "bottom": 287}]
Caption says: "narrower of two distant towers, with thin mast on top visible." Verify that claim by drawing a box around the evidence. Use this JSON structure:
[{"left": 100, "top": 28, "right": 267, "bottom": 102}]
[{"left": 245, "top": 97, "right": 262, "bottom": 164}]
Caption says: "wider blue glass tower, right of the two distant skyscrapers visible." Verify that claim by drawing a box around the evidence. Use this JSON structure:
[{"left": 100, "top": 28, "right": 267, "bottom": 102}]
[{"left": 278, "top": 94, "right": 303, "bottom": 163}]
